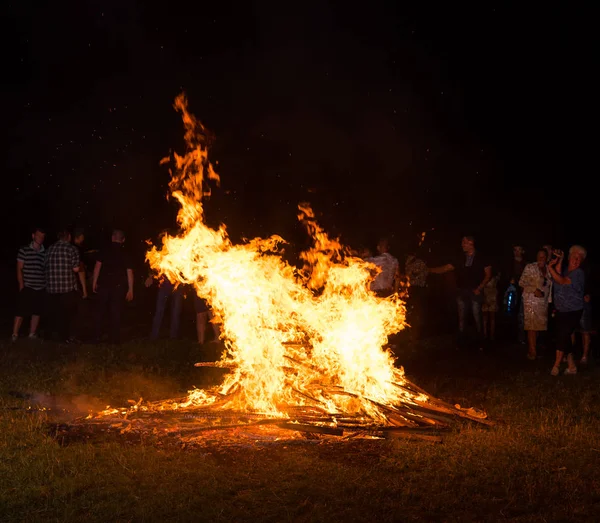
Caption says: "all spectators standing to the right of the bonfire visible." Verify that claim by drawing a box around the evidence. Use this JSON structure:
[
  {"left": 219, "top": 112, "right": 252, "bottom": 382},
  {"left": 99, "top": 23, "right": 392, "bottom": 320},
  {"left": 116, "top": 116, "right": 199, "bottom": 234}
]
[{"left": 363, "top": 236, "right": 592, "bottom": 376}]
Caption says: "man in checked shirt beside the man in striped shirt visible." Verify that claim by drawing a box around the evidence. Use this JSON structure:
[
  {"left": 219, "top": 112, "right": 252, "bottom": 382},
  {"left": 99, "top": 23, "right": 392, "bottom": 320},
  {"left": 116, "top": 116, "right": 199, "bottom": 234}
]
[{"left": 46, "top": 229, "right": 80, "bottom": 343}]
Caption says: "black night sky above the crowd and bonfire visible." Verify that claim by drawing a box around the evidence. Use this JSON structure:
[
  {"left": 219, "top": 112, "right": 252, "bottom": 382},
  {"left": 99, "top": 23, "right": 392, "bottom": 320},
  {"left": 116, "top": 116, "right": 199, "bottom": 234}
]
[{"left": 2, "top": 0, "right": 597, "bottom": 268}]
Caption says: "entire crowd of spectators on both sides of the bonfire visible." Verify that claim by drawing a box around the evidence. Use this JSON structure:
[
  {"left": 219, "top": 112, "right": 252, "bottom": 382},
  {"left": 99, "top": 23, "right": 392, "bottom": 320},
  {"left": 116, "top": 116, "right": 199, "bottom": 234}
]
[{"left": 12, "top": 228, "right": 592, "bottom": 376}]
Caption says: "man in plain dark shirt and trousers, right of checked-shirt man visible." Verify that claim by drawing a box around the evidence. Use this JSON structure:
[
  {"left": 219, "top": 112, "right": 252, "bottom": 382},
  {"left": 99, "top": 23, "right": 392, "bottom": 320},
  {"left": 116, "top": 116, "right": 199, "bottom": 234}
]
[{"left": 92, "top": 229, "right": 133, "bottom": 344}]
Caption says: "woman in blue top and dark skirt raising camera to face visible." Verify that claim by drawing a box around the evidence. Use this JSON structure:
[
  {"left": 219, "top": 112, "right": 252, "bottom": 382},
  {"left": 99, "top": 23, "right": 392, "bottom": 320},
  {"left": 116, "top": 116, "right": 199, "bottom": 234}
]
[{"left": 548, "top": 245, "right": 587, "bottom": 376}]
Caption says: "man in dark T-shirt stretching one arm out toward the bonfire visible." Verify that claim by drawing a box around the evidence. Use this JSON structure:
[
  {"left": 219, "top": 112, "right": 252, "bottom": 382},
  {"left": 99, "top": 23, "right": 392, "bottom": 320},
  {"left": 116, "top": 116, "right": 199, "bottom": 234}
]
[{"left": 429, "top": 236, "right": 492, "bottom": 349}]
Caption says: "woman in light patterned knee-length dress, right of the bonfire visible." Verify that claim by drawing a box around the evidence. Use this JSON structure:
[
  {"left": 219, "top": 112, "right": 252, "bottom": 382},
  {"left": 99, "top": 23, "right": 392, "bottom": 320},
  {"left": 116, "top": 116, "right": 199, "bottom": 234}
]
[{"left": 519, "top": 249, "right": 552, "bottom": 360}]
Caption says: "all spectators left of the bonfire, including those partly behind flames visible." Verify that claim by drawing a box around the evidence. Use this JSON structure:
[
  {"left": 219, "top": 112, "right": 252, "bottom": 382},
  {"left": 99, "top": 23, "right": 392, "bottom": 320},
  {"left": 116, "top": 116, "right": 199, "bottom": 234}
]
[{"left": 12, "top": 228, "right": 220, "bottom": 350}]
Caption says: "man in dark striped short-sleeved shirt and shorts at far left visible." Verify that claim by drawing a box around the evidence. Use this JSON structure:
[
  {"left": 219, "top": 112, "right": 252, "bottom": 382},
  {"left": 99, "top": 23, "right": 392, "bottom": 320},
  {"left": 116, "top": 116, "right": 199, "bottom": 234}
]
[{"left": 12, "top": 228, "right": 46, "bottom": 341}]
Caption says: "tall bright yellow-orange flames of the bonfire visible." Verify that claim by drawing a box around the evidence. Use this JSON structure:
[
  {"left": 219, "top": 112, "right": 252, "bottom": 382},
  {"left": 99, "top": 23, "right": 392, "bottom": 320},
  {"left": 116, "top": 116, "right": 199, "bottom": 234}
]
[{"left": 147, "top": 95, "right": 414, "bottom": 418}]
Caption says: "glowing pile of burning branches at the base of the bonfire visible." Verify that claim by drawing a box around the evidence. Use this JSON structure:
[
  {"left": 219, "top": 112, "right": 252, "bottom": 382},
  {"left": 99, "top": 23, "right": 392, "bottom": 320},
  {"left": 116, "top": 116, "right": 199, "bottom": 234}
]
[{"left": 51, "top": 357, "right": 493, "bottom": 443}]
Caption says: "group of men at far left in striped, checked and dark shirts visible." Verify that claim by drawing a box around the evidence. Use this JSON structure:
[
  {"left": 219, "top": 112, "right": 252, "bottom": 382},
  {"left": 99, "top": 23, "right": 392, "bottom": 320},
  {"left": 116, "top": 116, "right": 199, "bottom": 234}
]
[{"left": 12, "top": 228, "right": 133, "bottom": 343}]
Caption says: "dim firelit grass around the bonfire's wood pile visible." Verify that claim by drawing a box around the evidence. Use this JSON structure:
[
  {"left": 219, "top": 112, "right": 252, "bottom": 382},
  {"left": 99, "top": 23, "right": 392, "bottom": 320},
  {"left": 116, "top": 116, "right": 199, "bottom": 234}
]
[{"left": 0, "top": 339, "right": 600, "bottom": 522}]
